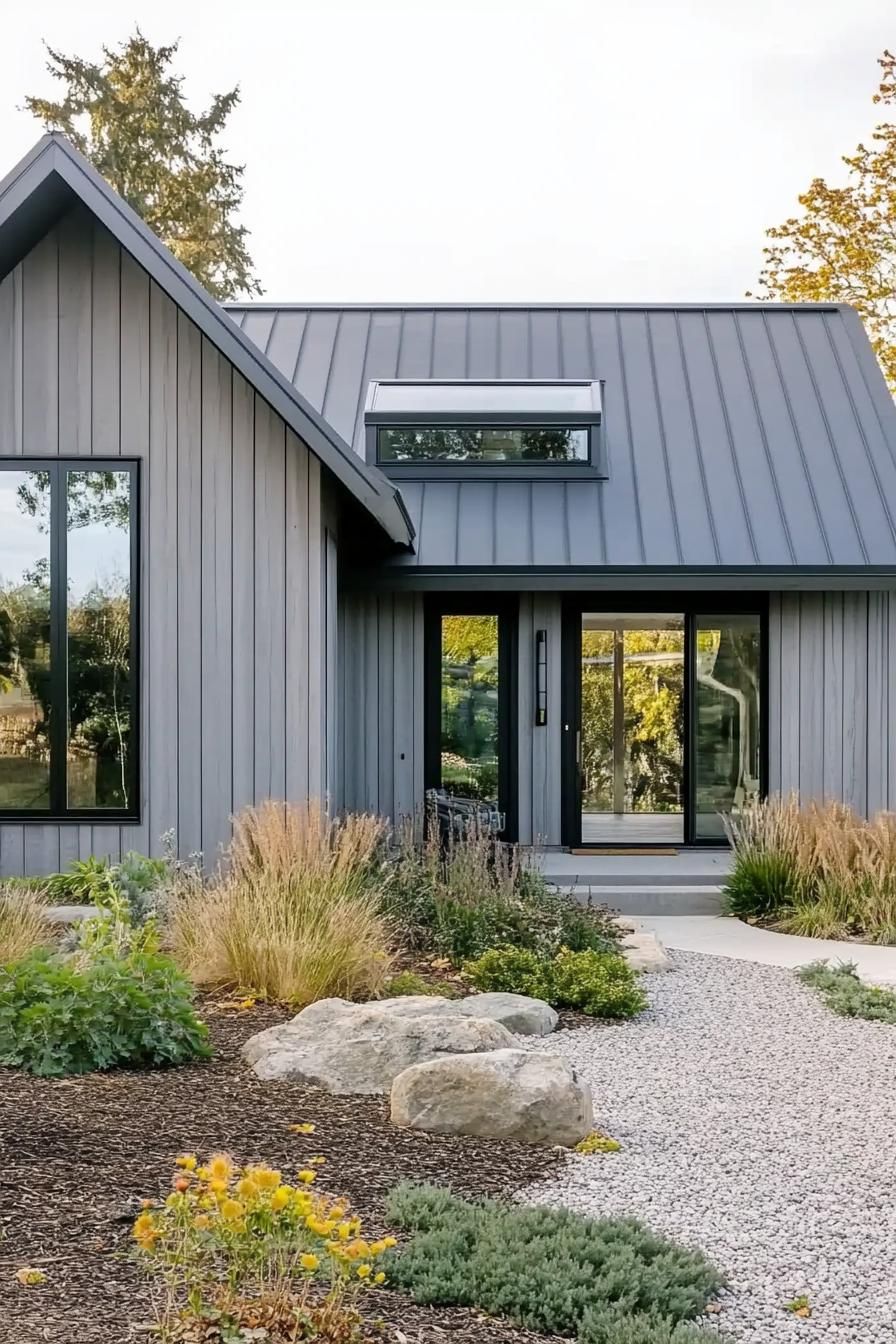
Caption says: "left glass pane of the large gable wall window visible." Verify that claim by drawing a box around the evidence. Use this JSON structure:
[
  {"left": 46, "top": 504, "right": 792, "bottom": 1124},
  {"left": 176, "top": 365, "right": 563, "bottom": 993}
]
[{"left": 0, "top": 470, "right": 51, "bottom": 812}]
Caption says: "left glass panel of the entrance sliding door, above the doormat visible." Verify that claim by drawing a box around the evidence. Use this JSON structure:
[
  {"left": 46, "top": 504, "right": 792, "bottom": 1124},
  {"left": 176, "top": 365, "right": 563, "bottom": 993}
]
[{"left": 578, "top": 612, "right": 685, "bottom": 845}]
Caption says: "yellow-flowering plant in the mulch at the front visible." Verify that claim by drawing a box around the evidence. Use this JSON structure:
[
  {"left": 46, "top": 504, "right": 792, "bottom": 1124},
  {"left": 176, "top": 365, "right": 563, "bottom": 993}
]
[{"left": 133, "top": 1153, "right": 395, "bottom": 1344}]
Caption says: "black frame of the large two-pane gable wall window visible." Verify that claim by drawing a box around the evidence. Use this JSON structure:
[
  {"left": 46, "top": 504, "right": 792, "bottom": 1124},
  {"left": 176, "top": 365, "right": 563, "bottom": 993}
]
[{"left": 0, "top": 457, "right": 141, "bottom": 825}]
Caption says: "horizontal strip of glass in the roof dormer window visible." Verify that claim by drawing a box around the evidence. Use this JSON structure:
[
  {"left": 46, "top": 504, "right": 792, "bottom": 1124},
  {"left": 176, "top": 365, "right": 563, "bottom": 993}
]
[{"left": 377, "top": 425, "right": 588, "bottom": 462}]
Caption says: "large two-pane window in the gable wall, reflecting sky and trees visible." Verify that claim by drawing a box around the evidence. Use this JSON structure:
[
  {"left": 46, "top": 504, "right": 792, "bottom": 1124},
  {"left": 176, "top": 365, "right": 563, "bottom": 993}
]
[{"left": 0, "top": 458, "right": 138, "bottom": 821}]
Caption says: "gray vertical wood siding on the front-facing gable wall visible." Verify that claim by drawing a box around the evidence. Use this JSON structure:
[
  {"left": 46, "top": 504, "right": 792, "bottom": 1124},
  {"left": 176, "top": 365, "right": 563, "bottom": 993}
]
[{"left": 0, "top": 198, "right": 337, "bottom": 876}]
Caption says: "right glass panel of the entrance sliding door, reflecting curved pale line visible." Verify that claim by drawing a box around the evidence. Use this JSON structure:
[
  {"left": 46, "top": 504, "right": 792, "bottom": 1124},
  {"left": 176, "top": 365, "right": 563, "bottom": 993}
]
[{"left": 692, "top": 614, "right": 763, "bottom": 840}]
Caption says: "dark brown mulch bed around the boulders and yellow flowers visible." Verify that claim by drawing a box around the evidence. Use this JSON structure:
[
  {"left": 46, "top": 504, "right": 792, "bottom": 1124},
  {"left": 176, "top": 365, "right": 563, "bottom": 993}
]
[{"left": 0, "top": 1003, "right": 564, "bottom": 1344}]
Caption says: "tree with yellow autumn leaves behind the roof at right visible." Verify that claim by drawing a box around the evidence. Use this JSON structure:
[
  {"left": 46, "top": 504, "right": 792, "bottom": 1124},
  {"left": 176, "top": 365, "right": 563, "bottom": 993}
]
[{"left": 747, "top": 51, "right": 896, "bottom": 392}]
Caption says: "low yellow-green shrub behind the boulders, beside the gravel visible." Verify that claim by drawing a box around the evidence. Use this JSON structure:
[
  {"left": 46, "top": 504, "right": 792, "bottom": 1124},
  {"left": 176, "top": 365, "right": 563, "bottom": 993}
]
[{"left": 465, "top": 948, "right": 647, "bottom": 1017}]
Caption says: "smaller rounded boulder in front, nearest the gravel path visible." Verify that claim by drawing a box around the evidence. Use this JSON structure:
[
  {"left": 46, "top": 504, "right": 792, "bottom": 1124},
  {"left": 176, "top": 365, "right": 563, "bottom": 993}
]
[{"left": 391, "top": 1050, "right": 592, "bottom": 1146}]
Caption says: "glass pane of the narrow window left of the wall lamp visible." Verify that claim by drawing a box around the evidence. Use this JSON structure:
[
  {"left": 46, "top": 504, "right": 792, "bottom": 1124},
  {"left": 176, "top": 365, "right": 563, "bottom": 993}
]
[{"left": 439, "top": 616, "right": 498, "bottom": 804}]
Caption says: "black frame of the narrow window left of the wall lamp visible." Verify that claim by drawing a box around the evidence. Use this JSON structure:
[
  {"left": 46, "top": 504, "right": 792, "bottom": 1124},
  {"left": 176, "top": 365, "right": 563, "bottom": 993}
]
[{"left": 423, "top": 593, "right": 520, "bottom": 840}]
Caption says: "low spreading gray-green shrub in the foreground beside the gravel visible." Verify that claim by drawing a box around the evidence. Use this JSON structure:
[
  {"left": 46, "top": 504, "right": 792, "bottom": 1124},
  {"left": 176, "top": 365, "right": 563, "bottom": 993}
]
[{"left": 386, "top": 1184, "right": 723, "bottom": 1344}]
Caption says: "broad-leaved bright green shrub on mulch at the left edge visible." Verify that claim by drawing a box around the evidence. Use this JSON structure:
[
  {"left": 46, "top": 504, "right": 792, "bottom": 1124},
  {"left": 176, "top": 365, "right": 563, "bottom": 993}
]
[{"left": 0, "top": 950, "right": 210, "bottom": 1078}]
